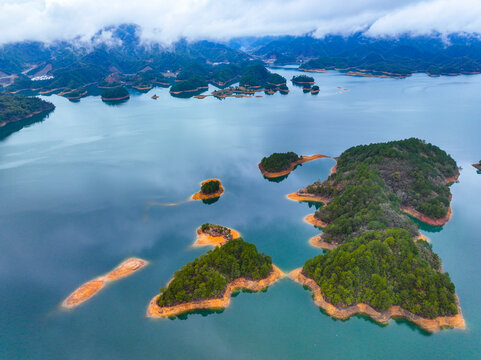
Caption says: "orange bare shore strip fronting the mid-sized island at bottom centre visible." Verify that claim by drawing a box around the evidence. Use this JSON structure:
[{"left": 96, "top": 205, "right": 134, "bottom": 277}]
[{"left": 146, "top": 265, "right": 284, "bottom": 318}]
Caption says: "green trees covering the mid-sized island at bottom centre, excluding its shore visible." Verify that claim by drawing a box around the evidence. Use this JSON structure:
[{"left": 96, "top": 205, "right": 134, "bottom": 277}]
[{"left": 157, "top": 238, "right": 272, "bottom": 306}]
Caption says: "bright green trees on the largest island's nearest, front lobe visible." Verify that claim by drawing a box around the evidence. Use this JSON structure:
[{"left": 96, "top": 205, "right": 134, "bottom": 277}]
[{"left": 302, "top": 229, "right": 457, "bottom": 318}]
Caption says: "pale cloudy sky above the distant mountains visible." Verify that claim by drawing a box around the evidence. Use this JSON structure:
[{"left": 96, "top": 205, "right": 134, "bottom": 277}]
[{"left": 0, "top": 0, "right": 481, "bottom": 44}]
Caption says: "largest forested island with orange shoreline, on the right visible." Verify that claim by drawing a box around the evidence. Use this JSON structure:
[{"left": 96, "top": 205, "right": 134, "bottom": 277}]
[{"left": 286, "top": 138, "right": 464, "bottom": 331}]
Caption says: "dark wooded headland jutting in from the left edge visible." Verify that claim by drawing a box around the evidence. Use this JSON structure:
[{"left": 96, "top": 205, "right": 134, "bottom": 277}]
[{"left": 0, "top": 93, "right": 55, "bottom": 123}]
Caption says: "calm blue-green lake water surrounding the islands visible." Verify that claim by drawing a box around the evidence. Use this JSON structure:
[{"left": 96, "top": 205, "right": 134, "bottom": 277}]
[{"left": 0, "top": 70, "right": 481, "bottom": 359}]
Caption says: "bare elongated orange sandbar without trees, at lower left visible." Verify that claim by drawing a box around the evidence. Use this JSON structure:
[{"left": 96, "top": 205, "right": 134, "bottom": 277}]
[{"left": 62, "top": 258, "right": 148, "bottom": 309}]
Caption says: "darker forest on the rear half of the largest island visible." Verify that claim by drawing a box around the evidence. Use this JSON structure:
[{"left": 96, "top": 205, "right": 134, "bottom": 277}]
[{"left": 306, "top": 138, "right": 458, "bottom": 243}]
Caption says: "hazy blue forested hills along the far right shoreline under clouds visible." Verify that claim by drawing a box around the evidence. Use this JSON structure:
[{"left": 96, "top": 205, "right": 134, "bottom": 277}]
[{"left": 251, "top": 33, "right": 481, "bottom": 76}]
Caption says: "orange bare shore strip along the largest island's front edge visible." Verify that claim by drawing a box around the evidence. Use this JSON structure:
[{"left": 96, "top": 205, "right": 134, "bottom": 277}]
[{"left": 288, "top": 268, "right": 466, "bottom": 332}]
